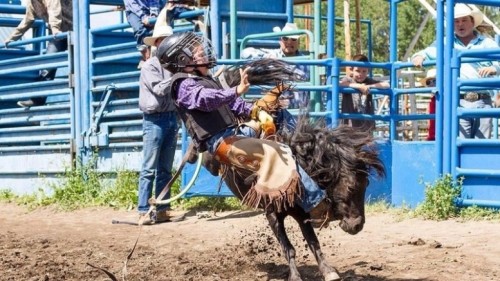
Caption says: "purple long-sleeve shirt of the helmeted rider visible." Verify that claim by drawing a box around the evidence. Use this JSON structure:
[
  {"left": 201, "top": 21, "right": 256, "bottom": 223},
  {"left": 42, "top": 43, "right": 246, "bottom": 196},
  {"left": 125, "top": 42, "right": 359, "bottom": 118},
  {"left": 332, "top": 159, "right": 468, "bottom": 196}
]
[{"left": 177, "top": 78, "right": 252, "bottom": 117}]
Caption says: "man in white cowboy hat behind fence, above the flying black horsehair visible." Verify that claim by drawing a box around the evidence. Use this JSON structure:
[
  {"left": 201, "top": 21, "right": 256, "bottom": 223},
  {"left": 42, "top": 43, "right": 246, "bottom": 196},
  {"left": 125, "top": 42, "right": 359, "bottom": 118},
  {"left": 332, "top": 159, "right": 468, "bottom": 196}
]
[{"left": 240, "top": 23, "right": 309, "bottom": 108}]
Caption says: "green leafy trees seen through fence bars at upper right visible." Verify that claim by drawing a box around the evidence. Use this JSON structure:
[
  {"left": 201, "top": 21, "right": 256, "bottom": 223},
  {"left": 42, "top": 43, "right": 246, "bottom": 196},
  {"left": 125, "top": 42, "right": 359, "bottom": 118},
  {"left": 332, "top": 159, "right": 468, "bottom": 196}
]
[{"left": 295, "top": 0, "right": 500, "bottom": 65}]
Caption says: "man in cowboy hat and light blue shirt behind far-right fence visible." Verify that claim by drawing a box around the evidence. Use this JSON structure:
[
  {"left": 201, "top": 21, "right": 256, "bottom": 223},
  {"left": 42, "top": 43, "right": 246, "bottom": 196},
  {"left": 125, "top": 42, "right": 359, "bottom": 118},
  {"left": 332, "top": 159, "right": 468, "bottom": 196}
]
[{"left": 412, "top": 4, "right": 500, "bottom": 139}]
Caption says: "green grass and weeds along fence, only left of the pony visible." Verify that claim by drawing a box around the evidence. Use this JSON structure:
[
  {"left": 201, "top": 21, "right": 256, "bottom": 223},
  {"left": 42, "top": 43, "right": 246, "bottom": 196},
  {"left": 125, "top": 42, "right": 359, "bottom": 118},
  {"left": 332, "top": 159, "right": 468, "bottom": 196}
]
[{"left": 0, "top": 154, "right": 243, "bottom": 211}]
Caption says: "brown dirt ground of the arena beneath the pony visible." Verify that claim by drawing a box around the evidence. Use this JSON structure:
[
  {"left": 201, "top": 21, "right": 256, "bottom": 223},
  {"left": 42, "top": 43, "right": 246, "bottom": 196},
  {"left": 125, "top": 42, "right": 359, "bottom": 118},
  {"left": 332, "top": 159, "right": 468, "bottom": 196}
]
[{"left": 0, "top": 203, "right": 500, "bottom": 281}]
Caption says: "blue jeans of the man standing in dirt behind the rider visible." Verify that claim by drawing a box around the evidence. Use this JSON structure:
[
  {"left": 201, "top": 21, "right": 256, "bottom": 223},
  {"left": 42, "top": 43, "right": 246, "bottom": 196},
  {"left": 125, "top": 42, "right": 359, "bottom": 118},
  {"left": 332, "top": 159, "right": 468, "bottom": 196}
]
[{"left": 138, "top": 111, "right": 179, "bottom": 213}]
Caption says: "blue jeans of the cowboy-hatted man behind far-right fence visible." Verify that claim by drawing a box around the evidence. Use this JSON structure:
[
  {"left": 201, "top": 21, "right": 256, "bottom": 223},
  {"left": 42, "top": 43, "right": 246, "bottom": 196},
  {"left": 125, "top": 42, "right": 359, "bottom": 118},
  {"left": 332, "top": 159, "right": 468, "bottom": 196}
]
[{"left": 459, "top": 98, "right": 493, "bottom": 139}]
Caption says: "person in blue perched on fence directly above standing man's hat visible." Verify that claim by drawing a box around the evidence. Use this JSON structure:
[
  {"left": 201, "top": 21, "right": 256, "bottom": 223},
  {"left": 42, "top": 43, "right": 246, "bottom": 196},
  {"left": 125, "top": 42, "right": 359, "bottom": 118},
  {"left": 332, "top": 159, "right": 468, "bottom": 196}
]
[{"left": 123, "top": 0, "right": 165, "bottom": 68}]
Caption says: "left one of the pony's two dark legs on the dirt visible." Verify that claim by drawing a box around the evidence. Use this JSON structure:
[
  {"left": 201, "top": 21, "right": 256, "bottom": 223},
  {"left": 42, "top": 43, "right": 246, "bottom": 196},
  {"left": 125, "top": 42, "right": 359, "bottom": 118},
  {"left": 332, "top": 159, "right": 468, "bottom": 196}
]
[{"left": 266, "top": 210, "right": 302, "bottom": 281}]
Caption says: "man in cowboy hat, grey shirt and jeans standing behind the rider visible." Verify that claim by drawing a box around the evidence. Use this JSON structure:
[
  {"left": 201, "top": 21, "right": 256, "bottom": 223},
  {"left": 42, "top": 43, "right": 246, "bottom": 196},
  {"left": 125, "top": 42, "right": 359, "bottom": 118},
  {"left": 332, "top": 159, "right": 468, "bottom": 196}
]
[{"left": 138, "top": 25, "right": 183, "bottom": 225}]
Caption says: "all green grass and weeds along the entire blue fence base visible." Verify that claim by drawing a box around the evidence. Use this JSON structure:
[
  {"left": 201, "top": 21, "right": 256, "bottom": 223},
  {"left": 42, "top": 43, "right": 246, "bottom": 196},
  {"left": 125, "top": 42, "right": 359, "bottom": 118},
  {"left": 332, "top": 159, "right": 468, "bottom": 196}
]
[{"left": 0, "top": 164, "right": 500, "bottom": 221}]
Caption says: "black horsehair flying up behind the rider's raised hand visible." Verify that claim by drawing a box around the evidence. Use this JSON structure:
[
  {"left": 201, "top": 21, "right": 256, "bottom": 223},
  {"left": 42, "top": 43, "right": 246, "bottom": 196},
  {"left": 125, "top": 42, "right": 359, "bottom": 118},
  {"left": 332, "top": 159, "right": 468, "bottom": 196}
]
[{"left": 219, "top": 58, "right": 306, "bottom": 87}]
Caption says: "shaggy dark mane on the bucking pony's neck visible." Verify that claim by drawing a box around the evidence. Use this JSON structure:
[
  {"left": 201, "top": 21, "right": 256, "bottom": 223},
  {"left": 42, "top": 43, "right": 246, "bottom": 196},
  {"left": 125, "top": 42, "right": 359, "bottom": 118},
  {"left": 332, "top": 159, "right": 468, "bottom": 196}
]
[{"left": 280, "top": 116, "right": 385, "bottom": 192}]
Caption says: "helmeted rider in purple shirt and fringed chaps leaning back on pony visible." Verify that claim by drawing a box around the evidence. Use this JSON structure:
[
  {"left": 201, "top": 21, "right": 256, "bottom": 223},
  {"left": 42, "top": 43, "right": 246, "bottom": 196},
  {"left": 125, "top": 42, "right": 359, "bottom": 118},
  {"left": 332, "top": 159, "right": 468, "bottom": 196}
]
[{"left": 157, "top": 32, "right": 326, "bottom": 219}]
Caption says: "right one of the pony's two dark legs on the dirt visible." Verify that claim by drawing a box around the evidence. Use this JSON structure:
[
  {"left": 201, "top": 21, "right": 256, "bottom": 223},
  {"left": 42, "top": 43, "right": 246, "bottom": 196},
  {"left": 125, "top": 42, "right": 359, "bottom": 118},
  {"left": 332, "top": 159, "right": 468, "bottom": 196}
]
[{"left": 293, "top": 208, "right": 340, "bottom": 281}]
